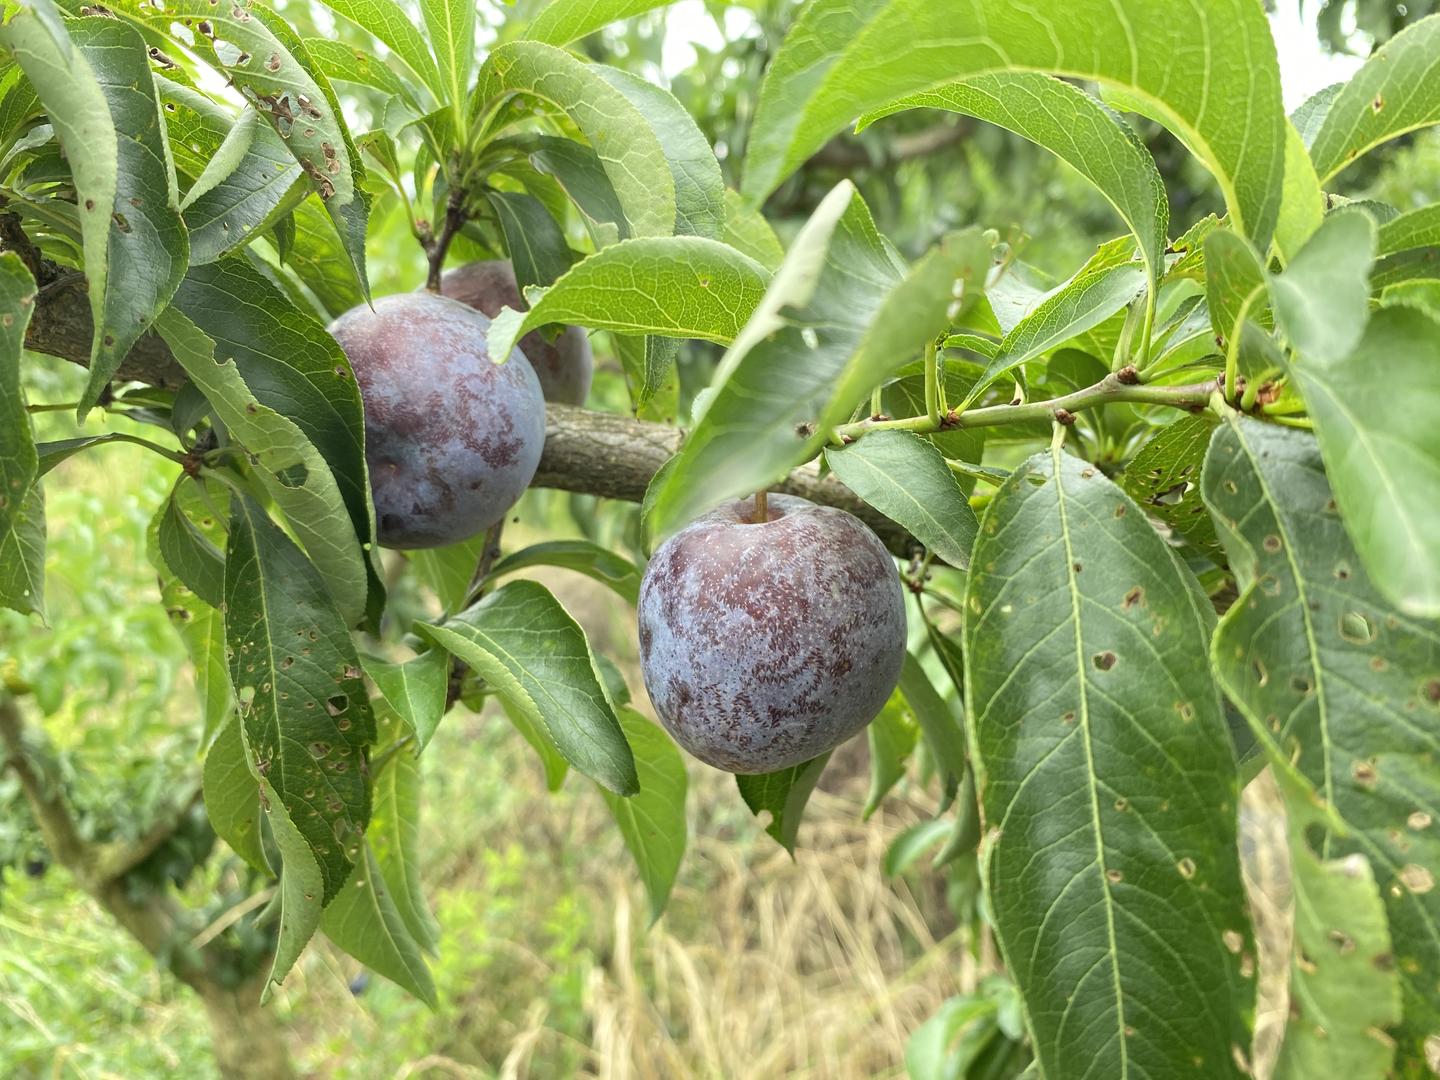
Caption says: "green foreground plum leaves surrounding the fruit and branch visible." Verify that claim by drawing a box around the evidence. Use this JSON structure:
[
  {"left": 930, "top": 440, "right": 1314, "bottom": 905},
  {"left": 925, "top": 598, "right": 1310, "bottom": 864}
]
[{"left": 0, "top": 0, "right": 1440, "bottom": 1080}]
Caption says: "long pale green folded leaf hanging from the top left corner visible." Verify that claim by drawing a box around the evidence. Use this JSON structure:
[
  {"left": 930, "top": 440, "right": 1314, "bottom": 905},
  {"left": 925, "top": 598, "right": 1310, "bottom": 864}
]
[{"left": 0, "top": 0, "right": 113, "bottom": 397}]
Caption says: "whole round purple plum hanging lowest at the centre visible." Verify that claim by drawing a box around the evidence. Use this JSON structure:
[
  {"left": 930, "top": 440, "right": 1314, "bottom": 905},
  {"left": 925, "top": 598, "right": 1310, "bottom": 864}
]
[{"left": 639, "top": 495, "right": 906, "bottom": 773}]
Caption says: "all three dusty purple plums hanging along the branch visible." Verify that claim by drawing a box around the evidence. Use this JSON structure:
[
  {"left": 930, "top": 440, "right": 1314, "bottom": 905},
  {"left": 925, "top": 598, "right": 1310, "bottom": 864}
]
[{"left": 330, "top": 261, "right": 906, "bottom": 773}]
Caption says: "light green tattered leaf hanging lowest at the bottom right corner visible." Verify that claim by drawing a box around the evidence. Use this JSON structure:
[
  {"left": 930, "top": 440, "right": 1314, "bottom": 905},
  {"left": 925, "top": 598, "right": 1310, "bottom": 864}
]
[{"left": 1274, "top": 775, "right": 1401, "bottom": 1080}]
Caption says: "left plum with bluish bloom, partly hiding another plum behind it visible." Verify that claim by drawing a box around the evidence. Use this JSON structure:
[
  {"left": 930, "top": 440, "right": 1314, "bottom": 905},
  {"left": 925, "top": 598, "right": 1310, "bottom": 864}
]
[{"left": 330, "top": 292, "right": 544, "bottom": 547}]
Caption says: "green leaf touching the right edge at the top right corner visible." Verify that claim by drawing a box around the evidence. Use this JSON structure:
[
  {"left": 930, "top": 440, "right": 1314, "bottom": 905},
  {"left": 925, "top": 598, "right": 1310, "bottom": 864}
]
[{"left": 1310, "top": 16, "right": 1440, "bottom": 181}]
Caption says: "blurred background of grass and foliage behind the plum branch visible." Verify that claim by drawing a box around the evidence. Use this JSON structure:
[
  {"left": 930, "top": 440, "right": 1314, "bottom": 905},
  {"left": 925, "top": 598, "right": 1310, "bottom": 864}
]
[{"left": 0, "top": 0, "right": 1440, "bottom": 1079}]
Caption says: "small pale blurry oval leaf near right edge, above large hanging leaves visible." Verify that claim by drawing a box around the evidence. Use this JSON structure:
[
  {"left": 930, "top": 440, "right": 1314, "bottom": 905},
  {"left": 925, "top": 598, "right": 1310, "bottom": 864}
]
[{"left": 1270, "top": 210, "right": 1375, "bottom": 363}]
